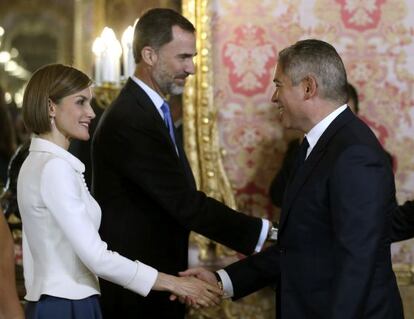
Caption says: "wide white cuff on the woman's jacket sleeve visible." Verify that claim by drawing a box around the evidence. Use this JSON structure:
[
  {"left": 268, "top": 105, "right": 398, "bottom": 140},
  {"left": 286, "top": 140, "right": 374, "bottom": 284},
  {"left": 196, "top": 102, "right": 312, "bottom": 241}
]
[{"left": 124, "top": 260, "right": 158, "bottom": 297}]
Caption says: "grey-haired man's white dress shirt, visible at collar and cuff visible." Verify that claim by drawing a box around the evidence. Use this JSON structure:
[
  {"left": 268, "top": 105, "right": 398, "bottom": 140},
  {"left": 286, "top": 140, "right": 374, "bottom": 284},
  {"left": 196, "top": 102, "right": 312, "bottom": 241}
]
[{"left": 217, "top": 104, "right": 347, "bottom": 298}]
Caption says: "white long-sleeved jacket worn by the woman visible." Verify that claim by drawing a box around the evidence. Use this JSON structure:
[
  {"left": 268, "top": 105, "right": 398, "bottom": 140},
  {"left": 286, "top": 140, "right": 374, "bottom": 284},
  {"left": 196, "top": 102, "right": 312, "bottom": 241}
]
[{"left": 17, "top": 137, "right": 158, "bottom": 301}]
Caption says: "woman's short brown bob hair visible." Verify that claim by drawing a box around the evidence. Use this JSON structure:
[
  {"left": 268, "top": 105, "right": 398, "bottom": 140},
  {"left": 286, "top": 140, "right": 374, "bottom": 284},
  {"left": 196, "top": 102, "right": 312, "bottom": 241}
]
[{"left": 23, "top": 64, "right": 92, "bottom": 134}]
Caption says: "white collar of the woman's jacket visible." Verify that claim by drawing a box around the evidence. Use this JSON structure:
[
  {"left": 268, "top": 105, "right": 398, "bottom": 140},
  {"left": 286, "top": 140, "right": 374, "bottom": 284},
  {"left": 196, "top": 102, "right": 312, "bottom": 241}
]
[{"left": 29, "top": 136, "right": 85, "bottom": 173}]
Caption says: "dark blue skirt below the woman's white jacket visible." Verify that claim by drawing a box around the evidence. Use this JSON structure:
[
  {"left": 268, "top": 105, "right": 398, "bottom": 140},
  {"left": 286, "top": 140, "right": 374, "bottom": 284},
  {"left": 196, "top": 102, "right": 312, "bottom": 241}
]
[{"left": 25, "top": 295, "right": 102, "bottom": 319}]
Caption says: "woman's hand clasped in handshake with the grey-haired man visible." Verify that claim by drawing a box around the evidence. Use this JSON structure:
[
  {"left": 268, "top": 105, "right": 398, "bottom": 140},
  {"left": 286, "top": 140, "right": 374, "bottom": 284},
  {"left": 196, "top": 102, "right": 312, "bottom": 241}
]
[{"left": 153, "top": 273, "right": 223, "bottom": 308}]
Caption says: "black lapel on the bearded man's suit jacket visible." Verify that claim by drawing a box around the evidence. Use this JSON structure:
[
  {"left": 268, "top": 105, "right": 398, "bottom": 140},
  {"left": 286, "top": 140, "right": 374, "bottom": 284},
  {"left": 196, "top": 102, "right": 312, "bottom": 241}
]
[{"left": 124, "top": 78, "right": 177, "bottom": 154}]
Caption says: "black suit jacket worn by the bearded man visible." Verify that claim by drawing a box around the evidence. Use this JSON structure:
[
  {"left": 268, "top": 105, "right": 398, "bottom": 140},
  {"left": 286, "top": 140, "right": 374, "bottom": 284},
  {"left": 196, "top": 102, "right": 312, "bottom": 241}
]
[{"left": 92, "top": 79, "right": 262, "bottom": 318}]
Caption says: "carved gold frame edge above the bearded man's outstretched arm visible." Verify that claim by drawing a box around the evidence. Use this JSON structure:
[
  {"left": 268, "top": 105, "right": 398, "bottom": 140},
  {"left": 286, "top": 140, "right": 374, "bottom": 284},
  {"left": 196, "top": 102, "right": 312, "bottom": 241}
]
[{"left": 183, "top": 0, "right": 236, "bottom": 208}]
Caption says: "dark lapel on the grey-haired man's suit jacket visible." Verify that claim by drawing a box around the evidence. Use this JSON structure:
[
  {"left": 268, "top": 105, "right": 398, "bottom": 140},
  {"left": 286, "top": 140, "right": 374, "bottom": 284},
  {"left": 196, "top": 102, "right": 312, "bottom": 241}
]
[{"left": 279, "top": 108, "right": 355, "bottom": 229}]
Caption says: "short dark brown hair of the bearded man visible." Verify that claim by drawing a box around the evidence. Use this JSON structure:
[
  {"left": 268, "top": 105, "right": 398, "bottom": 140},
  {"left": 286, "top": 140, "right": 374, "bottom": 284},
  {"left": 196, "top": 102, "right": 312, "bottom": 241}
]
[{"left": 132, "top": 8, "right": 195, "bottom": 63}]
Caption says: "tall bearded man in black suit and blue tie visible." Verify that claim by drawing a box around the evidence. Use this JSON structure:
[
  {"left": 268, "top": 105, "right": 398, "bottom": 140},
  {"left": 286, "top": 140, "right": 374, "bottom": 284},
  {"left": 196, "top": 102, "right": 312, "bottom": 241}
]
[{"left": 92, "top": 9, "right": 269, "bottom": 318}]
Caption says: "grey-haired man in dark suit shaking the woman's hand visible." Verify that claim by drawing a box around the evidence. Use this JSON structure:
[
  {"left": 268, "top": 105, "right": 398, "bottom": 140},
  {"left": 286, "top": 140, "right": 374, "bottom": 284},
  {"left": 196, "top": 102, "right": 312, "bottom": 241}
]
[{"left": 184, "top": 40, "right": 403, "bottom": 319}]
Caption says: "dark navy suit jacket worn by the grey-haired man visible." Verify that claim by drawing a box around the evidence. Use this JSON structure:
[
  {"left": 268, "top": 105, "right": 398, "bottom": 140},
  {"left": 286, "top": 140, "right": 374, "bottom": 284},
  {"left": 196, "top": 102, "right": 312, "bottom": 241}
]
[{"left": 226, "top": 109, "right": 403, "bottom": 319}]
